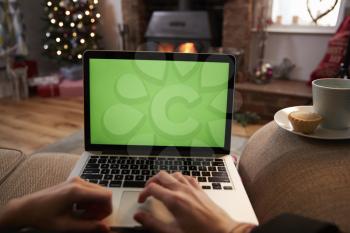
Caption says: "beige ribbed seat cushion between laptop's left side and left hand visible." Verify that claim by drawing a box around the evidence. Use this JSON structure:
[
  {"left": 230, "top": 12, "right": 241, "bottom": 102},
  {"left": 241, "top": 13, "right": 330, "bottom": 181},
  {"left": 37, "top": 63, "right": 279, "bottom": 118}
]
[{"left": 0, "top": 153, "right": 79, "bottom": 206}]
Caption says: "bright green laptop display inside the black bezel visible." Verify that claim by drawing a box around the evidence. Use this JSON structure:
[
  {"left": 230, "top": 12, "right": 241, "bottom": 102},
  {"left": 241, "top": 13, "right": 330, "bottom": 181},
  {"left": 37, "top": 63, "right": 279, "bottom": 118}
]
[{"left": 89, "top": 58, "right": 229, "bottom": 147}]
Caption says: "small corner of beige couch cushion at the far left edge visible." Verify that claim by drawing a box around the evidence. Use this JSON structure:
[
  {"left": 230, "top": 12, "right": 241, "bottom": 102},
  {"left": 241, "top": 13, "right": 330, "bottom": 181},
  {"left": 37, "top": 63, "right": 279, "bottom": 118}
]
[{"left": 0, "top": 148, "right": 26, "bottom": 185}]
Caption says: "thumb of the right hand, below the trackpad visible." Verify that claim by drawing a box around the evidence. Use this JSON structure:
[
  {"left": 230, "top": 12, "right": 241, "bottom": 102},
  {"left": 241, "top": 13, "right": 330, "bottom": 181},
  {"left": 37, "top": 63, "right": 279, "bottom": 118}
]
[{"left": 134, "top": 211, "right": 180, "bottom": 233}]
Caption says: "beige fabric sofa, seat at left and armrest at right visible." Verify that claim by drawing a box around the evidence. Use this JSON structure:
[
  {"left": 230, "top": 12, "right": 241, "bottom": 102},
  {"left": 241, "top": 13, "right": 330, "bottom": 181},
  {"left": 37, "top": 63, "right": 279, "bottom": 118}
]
[{"left": 0, "top": 122, "right": 350, "bottom": 232}]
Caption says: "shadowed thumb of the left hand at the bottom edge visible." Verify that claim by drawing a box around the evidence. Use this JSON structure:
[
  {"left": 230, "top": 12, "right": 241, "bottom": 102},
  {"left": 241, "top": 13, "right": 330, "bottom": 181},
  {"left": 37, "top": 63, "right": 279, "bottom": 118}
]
[{"left": 57, "top": 218, "right": 109, "bottom": 233}]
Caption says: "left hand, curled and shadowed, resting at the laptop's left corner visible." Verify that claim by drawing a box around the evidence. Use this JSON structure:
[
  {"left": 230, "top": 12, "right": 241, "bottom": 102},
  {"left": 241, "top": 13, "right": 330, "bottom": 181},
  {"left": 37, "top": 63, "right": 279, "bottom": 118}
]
[{"left": 0, "top": 177, "right": 112, "bottom": 232}]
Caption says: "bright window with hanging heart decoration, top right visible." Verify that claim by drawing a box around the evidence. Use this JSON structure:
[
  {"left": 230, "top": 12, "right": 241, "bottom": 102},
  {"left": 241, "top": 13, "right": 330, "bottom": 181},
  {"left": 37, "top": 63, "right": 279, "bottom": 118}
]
[{"left": 268, "top": 0, "right": 346, "bottom": 33}]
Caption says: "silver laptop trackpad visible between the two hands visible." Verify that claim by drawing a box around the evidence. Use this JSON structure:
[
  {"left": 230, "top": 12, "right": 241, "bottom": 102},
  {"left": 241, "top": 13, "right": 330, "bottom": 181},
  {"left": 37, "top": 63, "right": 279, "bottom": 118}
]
[{"left": 118, "top": 191, "right": 140, "bottom": 227}]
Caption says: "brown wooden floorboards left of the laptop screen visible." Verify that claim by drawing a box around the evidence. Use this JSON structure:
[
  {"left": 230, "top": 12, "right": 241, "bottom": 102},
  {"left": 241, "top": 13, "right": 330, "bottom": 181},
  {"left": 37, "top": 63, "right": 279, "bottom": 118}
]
[{"left": 0, "top": 97, "right": 83, "bottom": 154}]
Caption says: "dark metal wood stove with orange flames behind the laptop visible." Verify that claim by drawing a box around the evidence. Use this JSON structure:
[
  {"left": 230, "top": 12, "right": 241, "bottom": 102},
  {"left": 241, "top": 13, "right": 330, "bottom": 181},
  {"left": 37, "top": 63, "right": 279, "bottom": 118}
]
[{"left": 145, "top": 0, "right": 212, "bottom": 53}]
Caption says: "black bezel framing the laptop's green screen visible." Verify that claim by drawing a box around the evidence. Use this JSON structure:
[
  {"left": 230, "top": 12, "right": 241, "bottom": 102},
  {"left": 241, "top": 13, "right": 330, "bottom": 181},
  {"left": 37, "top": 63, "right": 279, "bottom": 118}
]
[{"left": 83, "top": 50, "right": 236, "bottom": 156}]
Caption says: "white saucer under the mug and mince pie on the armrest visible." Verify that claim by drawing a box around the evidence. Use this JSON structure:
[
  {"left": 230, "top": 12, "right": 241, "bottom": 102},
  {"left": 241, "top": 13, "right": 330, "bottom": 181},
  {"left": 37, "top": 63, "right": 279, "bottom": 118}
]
[{"left": 274, "top": 106, "right": 350, "bottom": 140}]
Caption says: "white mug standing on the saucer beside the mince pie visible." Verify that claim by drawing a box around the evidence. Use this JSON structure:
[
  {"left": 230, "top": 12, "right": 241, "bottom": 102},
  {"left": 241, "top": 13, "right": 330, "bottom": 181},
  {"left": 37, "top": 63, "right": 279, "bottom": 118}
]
[{"left": 312, "top": 78, "right": 350, "bottom": 130}]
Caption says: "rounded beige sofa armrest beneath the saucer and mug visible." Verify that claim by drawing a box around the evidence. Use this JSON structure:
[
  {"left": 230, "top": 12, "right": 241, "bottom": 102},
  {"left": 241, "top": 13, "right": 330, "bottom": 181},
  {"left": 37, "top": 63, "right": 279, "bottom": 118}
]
[{"left": 239, "top": 122, "right": 350, "bottom": 232}]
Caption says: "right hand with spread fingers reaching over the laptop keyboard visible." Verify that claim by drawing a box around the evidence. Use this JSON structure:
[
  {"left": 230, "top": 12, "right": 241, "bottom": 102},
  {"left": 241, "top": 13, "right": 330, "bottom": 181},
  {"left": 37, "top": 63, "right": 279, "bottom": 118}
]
[{"left": 134, "top": 171, "right": 240, "bottom": 233}]
